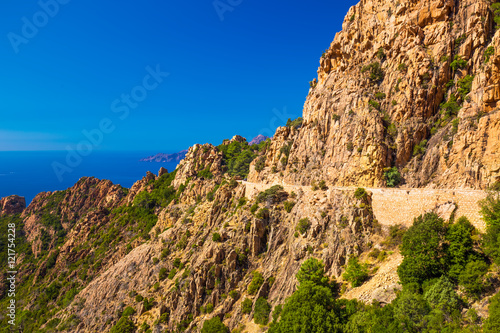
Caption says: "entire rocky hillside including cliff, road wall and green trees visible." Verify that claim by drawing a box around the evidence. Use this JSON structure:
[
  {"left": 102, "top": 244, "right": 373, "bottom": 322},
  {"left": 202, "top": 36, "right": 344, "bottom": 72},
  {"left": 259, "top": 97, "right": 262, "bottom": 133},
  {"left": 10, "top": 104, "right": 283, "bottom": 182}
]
[{"left": 0, "top": 0, "right": 500, "bottom": 333}]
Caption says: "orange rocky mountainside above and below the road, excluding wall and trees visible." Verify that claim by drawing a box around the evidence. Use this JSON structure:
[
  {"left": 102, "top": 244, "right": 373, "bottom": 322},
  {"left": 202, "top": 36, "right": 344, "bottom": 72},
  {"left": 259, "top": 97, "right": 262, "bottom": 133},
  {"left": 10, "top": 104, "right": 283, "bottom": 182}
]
[{"left": 0, "top": 0, "right": 500, "bottom": 332}]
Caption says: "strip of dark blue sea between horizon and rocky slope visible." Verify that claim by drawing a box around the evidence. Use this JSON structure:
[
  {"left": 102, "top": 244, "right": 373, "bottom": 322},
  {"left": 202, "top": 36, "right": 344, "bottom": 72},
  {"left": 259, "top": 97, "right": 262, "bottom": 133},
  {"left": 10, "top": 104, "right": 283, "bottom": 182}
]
[{"left": 0, "top": 151, "right": 178, "bottom": 205}]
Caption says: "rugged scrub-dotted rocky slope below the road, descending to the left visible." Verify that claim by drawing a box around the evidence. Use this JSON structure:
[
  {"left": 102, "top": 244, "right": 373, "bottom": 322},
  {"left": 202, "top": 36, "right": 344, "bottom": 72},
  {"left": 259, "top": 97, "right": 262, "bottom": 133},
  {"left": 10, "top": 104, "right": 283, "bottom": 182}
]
[{"left": 0, "top": 144, "right": 376, "bottom": 332}]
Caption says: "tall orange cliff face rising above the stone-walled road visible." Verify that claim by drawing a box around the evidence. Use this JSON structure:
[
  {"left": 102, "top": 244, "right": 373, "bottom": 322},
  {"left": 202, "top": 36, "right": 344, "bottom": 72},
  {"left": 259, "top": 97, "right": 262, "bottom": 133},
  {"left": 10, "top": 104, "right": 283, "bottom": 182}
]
[{"left": 249, "top": 0, "right": 500, "bottom": 188}]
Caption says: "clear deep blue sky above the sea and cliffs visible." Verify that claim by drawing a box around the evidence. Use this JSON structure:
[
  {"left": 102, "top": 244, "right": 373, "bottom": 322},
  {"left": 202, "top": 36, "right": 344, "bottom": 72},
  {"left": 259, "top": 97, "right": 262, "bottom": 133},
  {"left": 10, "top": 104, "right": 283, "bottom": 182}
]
[{"left": 0, "top": 0, "right": 356, "bottom": 152}]
